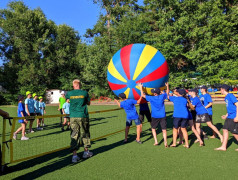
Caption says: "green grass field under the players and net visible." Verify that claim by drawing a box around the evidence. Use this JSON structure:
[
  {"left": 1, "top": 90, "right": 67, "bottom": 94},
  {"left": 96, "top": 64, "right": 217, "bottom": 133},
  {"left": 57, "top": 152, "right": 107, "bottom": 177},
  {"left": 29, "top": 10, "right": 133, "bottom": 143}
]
[{"left": 0, "top": 104, "right": 238, "bottom": 179}]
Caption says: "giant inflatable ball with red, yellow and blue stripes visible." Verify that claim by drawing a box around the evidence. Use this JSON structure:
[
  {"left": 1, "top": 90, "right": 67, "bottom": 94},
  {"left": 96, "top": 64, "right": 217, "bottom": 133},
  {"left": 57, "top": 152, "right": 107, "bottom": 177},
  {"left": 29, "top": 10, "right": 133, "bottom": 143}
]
[{"left": 107, "top": 44, "right": 169, "bottom": 99}]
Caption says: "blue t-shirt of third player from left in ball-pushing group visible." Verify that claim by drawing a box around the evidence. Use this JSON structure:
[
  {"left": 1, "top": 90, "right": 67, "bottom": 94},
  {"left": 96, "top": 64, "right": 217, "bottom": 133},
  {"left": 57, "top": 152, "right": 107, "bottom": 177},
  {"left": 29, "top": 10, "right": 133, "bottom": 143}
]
[{"left": 169, "top": 96, "right": 188, "bottom": 119}]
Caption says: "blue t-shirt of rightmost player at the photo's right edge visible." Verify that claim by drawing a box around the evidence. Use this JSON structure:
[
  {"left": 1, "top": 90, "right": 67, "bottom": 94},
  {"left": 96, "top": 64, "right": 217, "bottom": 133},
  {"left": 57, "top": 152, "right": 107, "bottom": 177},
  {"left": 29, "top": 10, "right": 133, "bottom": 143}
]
[{"left": 225, "top": 93, "right": 238, "bottom": 119}]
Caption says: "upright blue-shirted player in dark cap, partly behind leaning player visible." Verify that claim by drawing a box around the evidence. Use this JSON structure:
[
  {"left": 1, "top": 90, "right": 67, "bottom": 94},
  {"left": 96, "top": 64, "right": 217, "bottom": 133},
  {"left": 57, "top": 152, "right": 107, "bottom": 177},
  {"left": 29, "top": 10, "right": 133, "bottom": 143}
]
[{"left": 199, "top": 86, "right": 216, "bottom": 139}]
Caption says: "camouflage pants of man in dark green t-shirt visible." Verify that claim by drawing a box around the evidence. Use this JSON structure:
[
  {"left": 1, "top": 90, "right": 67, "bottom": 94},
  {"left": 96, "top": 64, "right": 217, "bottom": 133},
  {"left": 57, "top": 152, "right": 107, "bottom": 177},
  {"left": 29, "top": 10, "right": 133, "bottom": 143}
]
[{"left": 70, "top": 118, "right": 91, "bottom": 152}]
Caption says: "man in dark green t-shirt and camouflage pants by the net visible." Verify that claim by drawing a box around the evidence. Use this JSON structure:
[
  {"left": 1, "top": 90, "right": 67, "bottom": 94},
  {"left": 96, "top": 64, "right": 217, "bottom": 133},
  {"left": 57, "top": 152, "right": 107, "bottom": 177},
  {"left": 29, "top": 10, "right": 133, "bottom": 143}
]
[{"left": 66, "top": 79, "right": 93, "bottom": 163}]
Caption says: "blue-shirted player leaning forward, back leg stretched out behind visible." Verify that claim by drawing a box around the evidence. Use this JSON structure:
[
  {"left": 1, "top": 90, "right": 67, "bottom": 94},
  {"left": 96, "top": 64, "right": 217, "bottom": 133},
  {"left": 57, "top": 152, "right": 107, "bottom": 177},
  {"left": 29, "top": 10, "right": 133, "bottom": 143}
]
[{"left": 191, "top": 88, "right": 223, "bottom": 142}]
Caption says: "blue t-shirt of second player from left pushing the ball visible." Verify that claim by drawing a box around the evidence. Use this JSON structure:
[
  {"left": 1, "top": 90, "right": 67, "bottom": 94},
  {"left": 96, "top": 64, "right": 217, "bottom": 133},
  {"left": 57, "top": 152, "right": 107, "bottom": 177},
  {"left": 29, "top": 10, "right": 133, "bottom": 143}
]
[{"left": 145, "top": 94, "right": 167, "bottom": 118}]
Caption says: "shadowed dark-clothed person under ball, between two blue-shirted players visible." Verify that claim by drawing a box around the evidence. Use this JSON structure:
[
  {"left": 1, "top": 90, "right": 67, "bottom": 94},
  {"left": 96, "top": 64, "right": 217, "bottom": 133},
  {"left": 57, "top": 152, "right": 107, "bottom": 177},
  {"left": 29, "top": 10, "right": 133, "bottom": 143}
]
[{"left": 139, "top": 99, "right": 151, "bottom": 131}]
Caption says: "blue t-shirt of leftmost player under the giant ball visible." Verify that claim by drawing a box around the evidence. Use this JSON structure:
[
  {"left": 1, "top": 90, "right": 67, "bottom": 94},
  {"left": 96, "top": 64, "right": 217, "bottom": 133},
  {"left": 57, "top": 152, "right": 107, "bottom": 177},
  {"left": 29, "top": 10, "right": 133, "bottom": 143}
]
[{"left": 120, "top": 99, "right": 139, "bottom": 120}]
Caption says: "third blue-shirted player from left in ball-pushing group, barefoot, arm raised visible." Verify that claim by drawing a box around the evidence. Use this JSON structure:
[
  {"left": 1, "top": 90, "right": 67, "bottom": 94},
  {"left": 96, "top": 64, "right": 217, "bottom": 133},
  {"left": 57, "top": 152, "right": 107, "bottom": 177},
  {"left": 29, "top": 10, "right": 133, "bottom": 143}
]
[{"left": 167, "top": 87, "right": 189, "bottom": 148}]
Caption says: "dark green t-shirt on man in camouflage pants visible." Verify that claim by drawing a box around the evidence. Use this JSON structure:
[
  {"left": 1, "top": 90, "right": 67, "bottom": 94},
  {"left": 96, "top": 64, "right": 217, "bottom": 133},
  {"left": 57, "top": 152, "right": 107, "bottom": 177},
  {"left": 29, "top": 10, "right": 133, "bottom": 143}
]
[{"left": 66, "top": 89, "right": 90, "bottom": 118}]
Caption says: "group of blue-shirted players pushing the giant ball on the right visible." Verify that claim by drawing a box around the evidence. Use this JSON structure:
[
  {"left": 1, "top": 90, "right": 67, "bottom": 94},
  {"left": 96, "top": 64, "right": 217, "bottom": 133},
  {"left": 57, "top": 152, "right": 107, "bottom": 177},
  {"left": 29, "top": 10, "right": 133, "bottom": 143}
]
[{"left": 115, "top": 83, "right": 238, "bottom": 151}]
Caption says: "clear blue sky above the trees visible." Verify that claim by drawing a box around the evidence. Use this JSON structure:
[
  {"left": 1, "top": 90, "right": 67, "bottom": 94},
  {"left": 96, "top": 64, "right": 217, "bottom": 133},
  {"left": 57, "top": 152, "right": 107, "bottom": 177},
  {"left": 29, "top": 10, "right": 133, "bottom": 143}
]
[{"left": 0, "top": 0, "right": 143, "bottom": 66}]
